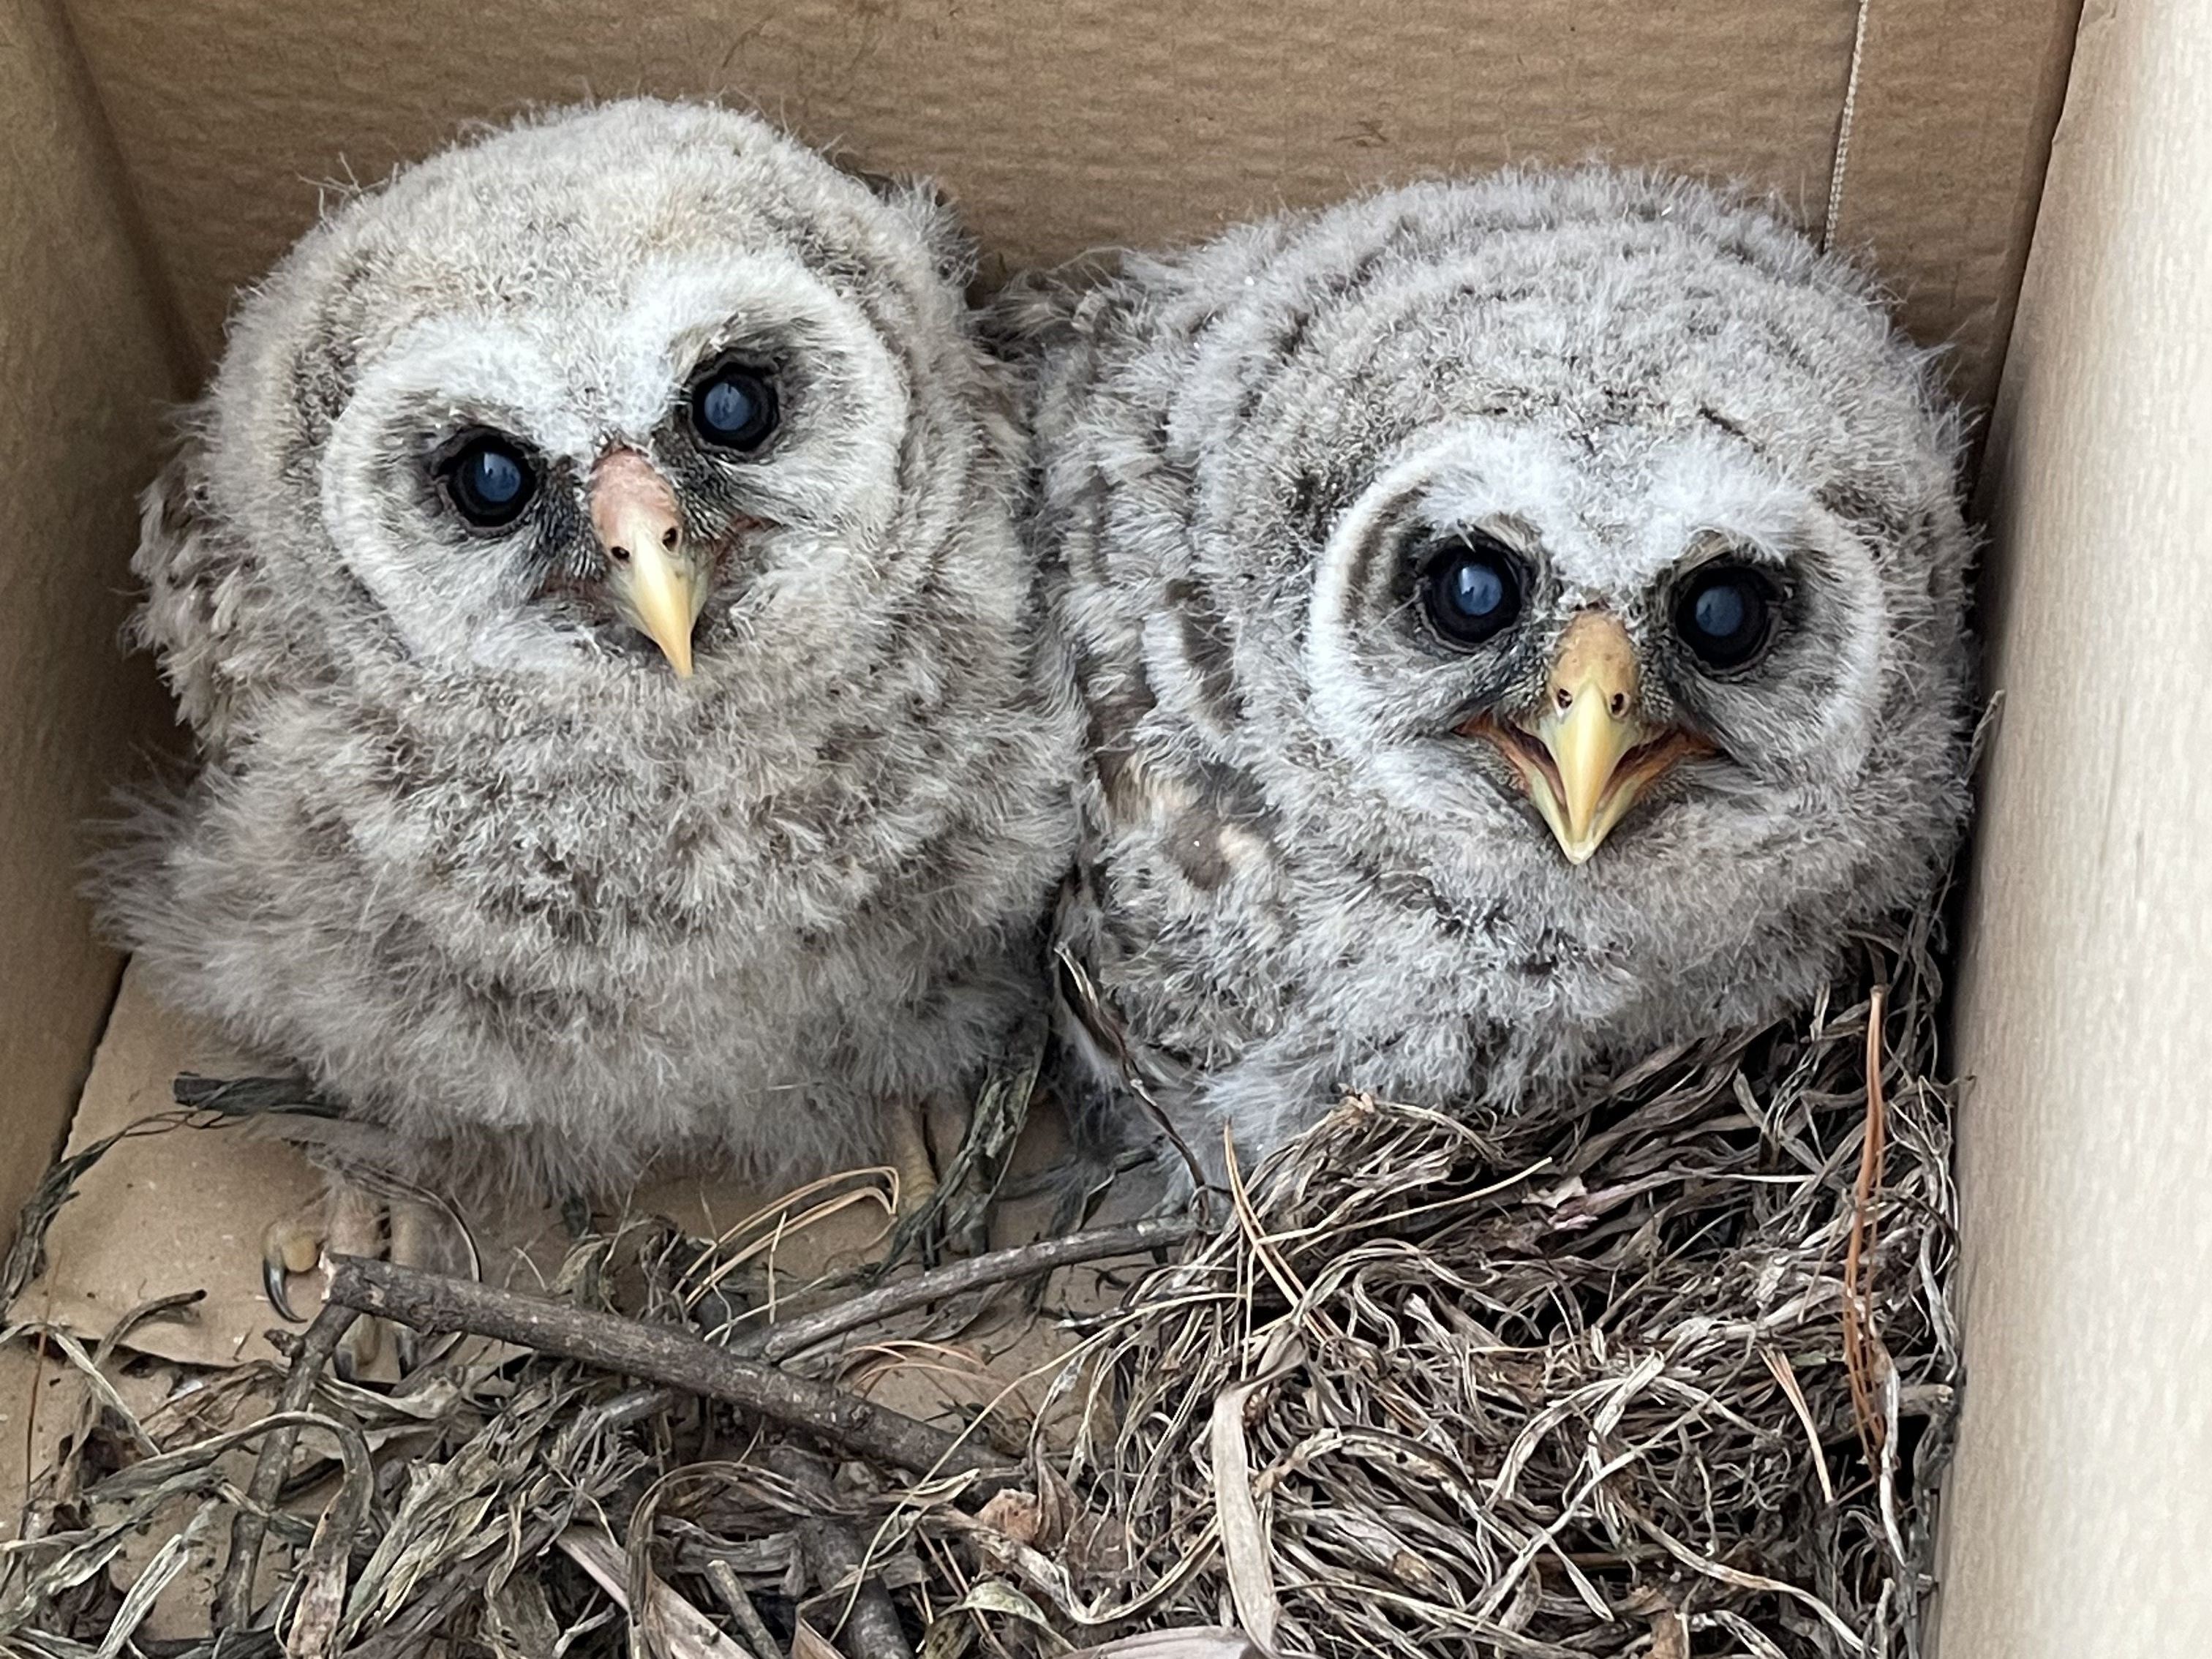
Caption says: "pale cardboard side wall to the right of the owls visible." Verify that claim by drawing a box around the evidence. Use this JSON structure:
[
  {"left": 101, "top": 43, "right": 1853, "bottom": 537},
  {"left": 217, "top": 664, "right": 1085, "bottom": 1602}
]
[{"left": 1942, "top": 0, "right": 2212, "bottom": 1659}]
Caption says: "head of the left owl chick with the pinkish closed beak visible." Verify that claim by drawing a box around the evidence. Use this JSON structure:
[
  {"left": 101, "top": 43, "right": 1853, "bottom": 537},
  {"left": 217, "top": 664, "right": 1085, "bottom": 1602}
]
[{"left": 195, "top": 102, "right": 998, "bottom": 697}]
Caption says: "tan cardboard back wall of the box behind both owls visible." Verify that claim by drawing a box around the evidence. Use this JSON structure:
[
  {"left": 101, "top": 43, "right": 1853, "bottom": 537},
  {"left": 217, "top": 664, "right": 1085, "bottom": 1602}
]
[{"left": 71, "top": 0, "right": 2080, "bottom": 409}]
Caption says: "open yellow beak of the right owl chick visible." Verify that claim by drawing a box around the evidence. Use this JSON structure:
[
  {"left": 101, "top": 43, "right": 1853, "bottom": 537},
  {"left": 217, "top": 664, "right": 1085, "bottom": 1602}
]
[{"left": 1464, "top": 611, "right": 1710, "bottom": 865}]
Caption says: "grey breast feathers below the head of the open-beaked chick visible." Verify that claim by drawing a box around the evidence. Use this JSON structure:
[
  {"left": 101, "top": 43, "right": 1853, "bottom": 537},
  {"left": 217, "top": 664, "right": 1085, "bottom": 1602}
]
[{"left": 1057, "top": 668, "right": 1858, "bottom": 1130}]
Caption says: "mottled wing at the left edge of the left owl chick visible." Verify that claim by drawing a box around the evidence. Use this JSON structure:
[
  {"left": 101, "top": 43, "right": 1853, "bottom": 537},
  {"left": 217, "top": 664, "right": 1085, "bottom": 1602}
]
[{"left": 130, "top": 415, "right": 268, "bottom": 759}]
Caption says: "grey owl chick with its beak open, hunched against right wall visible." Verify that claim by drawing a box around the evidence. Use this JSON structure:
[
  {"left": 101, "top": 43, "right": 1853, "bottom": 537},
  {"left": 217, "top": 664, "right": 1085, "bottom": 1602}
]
[{"left": 1015, "top": 170, "right": 1971, "bottom": 1177}]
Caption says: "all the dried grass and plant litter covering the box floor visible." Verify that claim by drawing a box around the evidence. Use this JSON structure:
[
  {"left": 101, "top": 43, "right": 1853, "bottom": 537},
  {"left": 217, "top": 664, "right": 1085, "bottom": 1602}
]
[{"left": 0, "top": 918, "right": 1960, "bottom": 1659}]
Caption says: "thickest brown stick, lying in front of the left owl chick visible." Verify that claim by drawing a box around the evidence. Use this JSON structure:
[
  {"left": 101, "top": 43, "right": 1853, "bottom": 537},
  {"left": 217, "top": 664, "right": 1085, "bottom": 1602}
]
[{"left": 330, "top": 1257, "right": 1015, "bottom": 1475}]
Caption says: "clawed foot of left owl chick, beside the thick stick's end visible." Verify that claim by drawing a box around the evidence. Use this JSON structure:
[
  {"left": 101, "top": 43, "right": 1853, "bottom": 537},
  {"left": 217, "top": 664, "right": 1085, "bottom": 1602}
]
[{"left": 261, "top": 1175, "right": 475, "bottom": 1382}]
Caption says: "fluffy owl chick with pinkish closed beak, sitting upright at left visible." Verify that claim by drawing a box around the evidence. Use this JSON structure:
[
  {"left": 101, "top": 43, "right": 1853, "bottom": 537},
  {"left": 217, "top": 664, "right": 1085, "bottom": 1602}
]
[{"left": 110, "top": 102, "right": 1077, "bottom": 1282}]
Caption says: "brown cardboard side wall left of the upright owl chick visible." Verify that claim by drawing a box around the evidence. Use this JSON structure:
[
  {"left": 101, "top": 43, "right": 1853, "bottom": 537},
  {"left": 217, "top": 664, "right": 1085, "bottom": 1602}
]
[{"left": 0, "top": 0, "right": 179, "bottom": 1234}]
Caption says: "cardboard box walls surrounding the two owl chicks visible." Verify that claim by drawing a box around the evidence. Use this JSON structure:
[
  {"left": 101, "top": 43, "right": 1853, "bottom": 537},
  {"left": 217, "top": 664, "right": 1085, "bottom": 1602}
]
[{"left": 0, "top": 0, "right": 2212, "bottom": 1659}]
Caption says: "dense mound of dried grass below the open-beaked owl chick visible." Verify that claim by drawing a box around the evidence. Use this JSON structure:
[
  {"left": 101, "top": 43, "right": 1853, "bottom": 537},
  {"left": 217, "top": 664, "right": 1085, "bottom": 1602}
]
[{"left": 1062, "top": 929, "right": 1960, "bottom": 1659}]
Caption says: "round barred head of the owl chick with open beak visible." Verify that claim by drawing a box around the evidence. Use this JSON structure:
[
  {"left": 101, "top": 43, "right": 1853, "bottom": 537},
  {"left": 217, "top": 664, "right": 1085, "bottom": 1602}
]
[{"left": 1039, "top": 170, "right": 1971, "bottom": 971}]
